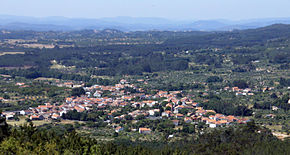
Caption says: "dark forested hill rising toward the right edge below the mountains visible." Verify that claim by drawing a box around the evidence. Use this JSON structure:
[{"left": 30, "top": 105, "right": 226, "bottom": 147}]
[{"left": 164, "top": 24, "right": 290, "bottom": 48}]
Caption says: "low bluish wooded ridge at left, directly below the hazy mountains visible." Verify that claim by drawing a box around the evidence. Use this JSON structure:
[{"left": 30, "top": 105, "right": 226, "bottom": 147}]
[{"left": 0, "top": 29, "right": 213, "bottom": 41}]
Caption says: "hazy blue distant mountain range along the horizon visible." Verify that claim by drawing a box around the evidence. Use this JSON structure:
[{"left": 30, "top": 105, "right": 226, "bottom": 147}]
[{"left": 0, "top": 15, "right": 290, "bottom": 31}]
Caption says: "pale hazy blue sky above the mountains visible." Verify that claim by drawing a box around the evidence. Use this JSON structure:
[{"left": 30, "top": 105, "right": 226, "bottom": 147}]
[{"left": 0, "top": 0, "right": 290, "bottom": 20}]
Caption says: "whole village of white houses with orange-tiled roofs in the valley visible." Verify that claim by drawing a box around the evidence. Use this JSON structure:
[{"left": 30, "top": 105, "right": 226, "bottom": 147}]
[{"left": 3, "top": 80, "right": 251, "bottom": 134}]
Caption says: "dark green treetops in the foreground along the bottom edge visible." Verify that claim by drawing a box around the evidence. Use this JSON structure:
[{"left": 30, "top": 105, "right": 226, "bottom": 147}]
[{"left": 0, "top": 119, "right": 290, "bottom": 155}]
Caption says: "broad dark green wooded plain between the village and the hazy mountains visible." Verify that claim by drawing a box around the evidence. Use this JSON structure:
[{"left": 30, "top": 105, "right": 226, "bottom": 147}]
[{"left": 0, "top": 24, "right": 290, "bottom": 77}]
